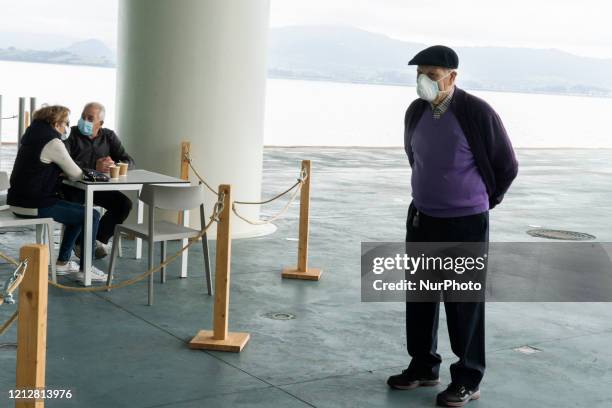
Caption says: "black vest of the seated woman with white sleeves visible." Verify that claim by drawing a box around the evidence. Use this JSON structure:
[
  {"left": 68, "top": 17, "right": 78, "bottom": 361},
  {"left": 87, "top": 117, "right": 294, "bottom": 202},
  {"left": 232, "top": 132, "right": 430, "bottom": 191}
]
[{"left": 6, "top": 120, "right": 61, "bottom": 208}]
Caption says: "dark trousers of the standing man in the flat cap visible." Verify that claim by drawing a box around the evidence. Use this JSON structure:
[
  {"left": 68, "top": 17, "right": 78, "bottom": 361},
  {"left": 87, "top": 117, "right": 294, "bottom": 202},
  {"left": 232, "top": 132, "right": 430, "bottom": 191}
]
[{"left": 406, "top": 204, "right": 489, "bottom": 388}]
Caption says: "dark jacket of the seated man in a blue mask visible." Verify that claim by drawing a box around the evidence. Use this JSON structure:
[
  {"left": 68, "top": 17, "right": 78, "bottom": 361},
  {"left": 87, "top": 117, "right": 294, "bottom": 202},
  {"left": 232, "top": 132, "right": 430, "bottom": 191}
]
[{"left": 64, "top": 126, "right": 134, "bottom": 169}]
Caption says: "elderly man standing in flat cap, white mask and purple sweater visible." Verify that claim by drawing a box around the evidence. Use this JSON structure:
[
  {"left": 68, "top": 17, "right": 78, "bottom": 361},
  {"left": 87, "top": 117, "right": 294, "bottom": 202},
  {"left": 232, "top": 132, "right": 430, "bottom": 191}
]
[{"left": 387, "top": 45, "right": 518, "bottom": 407}]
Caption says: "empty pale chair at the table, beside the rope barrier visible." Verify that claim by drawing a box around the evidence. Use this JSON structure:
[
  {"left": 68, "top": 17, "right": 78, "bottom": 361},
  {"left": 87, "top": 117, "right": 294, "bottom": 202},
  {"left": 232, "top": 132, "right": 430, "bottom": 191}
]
[{"left": 107, "top": 184, "right": 212, "bottom": 306}]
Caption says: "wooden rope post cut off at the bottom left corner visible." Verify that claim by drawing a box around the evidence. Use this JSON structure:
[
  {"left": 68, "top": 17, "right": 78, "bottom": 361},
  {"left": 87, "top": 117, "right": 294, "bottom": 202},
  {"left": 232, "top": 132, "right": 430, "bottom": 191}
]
[{"left": 15, "top": 244, "right": 49, "bottom": 408}]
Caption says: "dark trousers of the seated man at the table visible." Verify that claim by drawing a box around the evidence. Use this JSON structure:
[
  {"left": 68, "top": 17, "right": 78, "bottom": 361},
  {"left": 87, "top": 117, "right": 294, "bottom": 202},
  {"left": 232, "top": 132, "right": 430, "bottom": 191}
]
[{"left": 62, "top": 185, "right": 132, "bottom": 244}]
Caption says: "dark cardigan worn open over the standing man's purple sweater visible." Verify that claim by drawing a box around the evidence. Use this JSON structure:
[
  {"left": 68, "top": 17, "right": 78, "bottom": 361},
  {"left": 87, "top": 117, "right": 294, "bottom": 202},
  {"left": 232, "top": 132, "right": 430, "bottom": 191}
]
[{"left": 404, "top": 88, "right": 518, "bottom": 208}]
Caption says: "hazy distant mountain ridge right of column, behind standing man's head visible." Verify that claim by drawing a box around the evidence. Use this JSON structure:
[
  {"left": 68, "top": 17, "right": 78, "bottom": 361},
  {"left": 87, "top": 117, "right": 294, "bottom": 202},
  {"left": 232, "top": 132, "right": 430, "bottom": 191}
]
[{"left": 268, "top": 26, "right": 612, "bottom": 96}]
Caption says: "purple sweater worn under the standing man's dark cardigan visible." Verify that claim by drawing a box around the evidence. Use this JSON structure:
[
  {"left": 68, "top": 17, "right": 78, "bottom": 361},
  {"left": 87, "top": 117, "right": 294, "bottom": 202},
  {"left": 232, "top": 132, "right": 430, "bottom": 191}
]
[{"left": 411, "top": 108, "right": 489, "bottom": 218}]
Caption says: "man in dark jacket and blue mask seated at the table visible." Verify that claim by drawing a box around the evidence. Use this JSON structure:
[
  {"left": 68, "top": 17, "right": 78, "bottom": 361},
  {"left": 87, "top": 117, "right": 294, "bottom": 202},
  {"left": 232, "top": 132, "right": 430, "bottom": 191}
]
[{"left": 63, "top": 102, "right": 134, "bottom": 259}]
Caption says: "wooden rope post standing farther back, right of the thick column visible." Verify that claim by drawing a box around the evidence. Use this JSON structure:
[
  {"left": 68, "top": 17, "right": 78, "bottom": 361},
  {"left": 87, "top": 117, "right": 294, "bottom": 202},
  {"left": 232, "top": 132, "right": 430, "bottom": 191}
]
[{"left": 282, "top": 160, "right": 322, "bottom": 280}]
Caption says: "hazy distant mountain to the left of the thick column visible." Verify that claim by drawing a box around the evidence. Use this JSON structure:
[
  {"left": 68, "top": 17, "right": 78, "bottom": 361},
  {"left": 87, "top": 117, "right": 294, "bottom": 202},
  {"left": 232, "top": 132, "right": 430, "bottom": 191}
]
[{"left": 0, "top": 39, "right": 116, "bottom": 67}]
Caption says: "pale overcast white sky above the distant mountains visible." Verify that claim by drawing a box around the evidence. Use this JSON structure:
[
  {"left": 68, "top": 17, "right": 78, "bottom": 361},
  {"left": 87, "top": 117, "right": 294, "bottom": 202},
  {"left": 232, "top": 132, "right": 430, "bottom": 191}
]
[{"left": 0, "top": 0, "right": 612, "bottom": 58}]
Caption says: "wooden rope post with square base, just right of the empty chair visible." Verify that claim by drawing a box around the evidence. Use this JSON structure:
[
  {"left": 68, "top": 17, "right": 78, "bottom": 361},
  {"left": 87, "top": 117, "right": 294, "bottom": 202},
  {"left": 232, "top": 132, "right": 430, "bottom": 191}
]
[{"left": 189, "top": 184, "right": 250, "bottom": 352}]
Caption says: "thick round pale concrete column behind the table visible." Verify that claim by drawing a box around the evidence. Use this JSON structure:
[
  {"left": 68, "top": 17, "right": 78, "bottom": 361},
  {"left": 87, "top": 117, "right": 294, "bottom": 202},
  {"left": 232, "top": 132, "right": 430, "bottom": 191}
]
[{"left": 117, "top": 0, "right": 274, "bottom": 237}]
